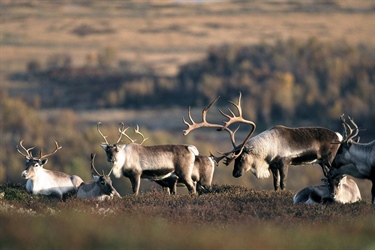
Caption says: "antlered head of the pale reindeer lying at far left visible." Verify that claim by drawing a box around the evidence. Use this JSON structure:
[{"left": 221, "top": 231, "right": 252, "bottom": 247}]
[{"left": 17, "top": 140, "right": 62, "bottom": 179}]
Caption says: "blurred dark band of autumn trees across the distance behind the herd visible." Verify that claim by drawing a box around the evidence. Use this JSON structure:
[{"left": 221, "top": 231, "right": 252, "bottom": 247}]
[{"left": 12, "top": 37, "right": 375, "bottom": 124}]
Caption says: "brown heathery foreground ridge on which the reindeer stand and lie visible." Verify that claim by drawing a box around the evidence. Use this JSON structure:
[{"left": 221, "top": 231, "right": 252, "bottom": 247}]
[{"left": 0, "top": 185, "right": 375, "bottom": 249}]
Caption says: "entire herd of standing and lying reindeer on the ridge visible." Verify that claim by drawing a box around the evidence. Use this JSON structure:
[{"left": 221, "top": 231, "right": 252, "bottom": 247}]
[{"left": 17, "top": 93, "right": 375, "bottom": 204}]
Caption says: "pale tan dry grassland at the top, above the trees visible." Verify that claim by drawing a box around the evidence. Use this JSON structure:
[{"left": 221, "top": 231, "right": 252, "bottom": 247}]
[{"left": 0, "top": 1, "right": 374, "bottom": 78}]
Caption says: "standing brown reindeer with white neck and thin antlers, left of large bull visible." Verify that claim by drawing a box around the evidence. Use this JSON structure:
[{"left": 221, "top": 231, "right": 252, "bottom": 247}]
[{"left": 97, "top": 123, "right": 199, "bottom": 195}]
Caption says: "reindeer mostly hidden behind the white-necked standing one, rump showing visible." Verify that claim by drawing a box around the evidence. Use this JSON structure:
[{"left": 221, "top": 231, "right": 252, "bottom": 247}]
[{"left": 155, "top": 155, "right": 217, "bottom": 194}]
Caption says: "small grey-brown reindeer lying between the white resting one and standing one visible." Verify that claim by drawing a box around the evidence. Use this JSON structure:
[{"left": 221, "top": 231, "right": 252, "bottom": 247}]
[{"left": 77, "top": 154, "right": 121, "bottom": 201}]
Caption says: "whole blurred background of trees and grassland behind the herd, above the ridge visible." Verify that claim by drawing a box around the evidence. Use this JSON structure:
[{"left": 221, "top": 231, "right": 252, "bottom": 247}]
[{"left": 0, "top": 0, "right": 375, "bottom": 199}]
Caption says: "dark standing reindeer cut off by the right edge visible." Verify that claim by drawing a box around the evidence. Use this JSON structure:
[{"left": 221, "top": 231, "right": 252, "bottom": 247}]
[{"left": 328, "top": 115, "right": 375, "bottom": 204}]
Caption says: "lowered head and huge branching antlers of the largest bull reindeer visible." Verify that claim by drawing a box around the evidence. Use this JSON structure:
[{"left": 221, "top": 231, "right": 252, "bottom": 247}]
[{"left": 183, "top": 93, "right": 256, "bottom": 178}]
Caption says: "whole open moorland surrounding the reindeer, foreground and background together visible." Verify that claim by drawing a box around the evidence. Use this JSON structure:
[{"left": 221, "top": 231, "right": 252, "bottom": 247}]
[{"left": 0, "top": 0, "right": 375, "bottom": 249}]
